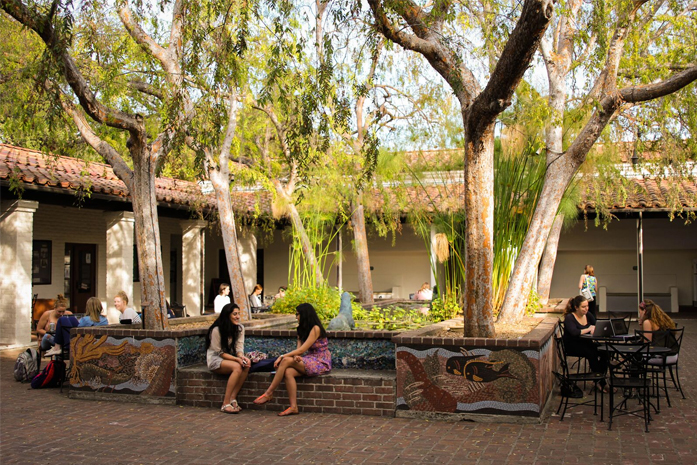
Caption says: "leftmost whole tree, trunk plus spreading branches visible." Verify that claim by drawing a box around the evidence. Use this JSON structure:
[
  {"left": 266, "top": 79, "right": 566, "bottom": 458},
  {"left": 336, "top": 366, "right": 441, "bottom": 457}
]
[{"left": 0, "top": 0, "right": 204, "bottom": 329}]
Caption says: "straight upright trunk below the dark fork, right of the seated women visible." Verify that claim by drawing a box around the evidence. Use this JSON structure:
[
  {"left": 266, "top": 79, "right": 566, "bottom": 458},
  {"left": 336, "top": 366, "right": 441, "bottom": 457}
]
[{"left": 463, "top": 112, "right": 496, "bottom": 337}]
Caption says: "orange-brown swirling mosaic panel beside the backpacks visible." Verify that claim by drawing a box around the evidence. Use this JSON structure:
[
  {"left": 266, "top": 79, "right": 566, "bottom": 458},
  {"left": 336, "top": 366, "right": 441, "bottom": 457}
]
[{"left": 69, "top": 334, "right": 176, "bottom": 397}]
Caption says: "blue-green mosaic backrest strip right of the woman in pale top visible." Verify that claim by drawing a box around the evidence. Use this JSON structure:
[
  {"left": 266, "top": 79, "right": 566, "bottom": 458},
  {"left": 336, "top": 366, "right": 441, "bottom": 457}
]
[{"left": 244, "top": 336, "right": 395, "bottom": 370}]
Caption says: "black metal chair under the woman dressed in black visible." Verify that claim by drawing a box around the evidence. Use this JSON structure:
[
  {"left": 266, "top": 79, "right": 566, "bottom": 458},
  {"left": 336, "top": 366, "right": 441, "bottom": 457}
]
[{"left": 553, "top": 334, "right": 605, "bottom": 421}]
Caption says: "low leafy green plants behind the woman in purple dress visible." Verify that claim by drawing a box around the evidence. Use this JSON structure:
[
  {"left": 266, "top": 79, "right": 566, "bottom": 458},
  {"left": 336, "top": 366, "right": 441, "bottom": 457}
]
[{"left": 272, "top": 286, "right": 362, "bottom": 324}]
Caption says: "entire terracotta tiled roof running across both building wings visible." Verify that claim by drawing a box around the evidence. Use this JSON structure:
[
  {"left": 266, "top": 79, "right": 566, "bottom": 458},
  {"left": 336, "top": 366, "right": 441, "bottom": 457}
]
[{"left": 0, "top": 144, "right": 697, "bottom": 214}]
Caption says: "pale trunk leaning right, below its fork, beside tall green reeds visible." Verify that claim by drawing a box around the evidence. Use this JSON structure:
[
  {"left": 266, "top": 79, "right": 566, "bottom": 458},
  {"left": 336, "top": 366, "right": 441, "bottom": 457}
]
[{"left": 499, "top": 155, "right": 580, "bottom": 323}]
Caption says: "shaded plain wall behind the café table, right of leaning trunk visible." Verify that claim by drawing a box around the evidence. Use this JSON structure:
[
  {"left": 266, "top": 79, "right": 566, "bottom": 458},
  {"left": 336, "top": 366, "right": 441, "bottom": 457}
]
[{"left": 550, "top": 218, "right": 697, "bottom": 305}]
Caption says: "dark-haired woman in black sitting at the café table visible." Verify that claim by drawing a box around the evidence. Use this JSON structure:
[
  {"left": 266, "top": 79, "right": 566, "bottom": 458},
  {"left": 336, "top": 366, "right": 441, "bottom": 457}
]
[{"left": 564, "top": 295, "right": 608, "bottom": 392}]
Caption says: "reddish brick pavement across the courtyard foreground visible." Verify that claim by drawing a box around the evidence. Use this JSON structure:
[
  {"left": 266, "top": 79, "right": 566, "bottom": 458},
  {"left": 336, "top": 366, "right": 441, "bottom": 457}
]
[{"left": 0, "top": 320, "right": 697, "bottom": 465}]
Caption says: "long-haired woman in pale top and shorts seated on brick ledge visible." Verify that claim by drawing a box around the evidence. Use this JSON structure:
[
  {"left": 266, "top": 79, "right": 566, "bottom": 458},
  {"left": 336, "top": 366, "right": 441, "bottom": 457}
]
[{"left": 206, "top": 304, "right": 252, "bottom": 413}]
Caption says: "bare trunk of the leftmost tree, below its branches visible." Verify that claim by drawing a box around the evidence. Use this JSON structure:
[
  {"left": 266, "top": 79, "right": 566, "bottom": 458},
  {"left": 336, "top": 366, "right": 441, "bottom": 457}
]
[{"left": 130, "top": 147, "right": 169, "bottom": 329}]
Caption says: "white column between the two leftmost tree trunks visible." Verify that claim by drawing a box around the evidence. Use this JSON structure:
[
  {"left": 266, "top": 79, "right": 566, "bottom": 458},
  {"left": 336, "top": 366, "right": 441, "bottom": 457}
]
[{"left": 180, "top": 220, "right": 207, "bottom": 315}]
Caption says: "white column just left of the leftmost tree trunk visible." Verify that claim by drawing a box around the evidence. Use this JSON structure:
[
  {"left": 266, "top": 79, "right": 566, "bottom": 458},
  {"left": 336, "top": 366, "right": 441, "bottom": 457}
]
[{"left": 104, "top": 212, "right": 139, "bottom": 324}]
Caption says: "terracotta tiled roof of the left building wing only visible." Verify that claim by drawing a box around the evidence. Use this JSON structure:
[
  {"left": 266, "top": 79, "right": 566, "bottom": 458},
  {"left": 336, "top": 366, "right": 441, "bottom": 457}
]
[{"left": 0, "top": 144, "right": 268, "bottom": 213}]
